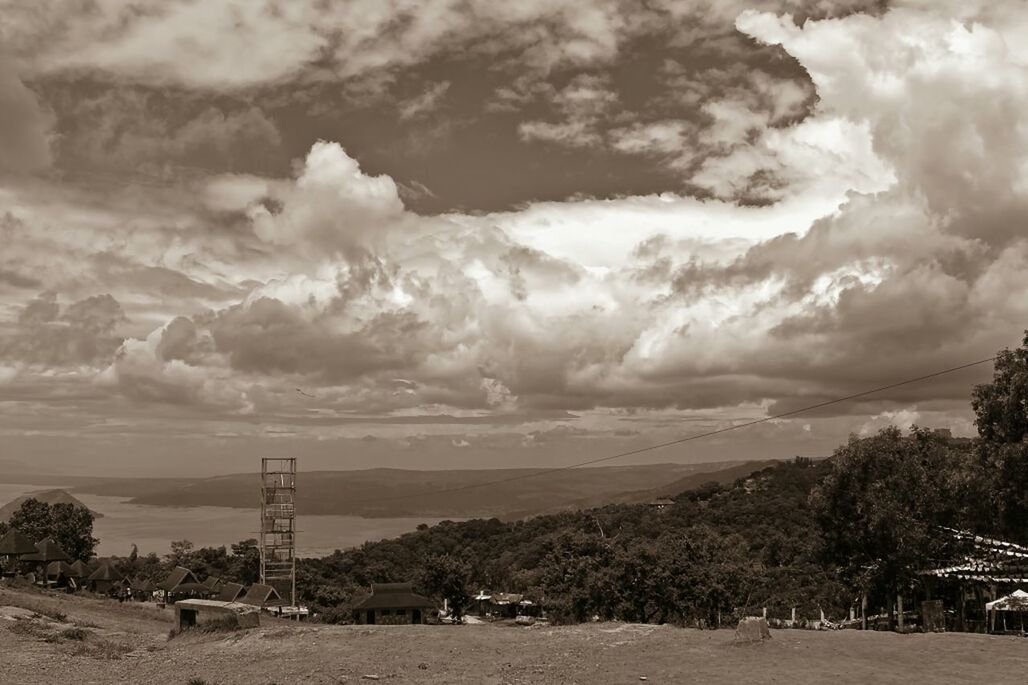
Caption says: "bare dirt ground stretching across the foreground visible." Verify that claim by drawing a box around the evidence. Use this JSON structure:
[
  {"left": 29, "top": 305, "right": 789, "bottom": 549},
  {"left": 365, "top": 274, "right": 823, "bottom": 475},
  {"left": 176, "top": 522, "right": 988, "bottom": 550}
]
[{"left": 0, "top": 589, "right": 1028, "bottom": 685}]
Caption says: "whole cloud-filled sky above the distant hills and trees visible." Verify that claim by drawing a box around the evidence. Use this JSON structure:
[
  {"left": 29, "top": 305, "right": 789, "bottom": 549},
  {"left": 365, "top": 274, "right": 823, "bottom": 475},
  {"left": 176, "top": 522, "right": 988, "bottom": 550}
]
[{"left": 0, "top": 0, "right": 1028, "bottom": 476}]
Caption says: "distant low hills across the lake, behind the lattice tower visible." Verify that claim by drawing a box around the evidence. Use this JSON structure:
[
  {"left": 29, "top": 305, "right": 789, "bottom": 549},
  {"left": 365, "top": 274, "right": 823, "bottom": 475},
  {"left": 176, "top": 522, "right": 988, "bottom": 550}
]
[{"left": 68, "top": 462, "right": 755, "bottom": 518}]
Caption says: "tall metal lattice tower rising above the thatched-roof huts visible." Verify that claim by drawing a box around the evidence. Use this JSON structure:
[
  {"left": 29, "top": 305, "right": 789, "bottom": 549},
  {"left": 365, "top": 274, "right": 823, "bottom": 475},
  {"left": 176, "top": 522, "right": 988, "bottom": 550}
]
[{"left": 260, "top": 458, "right": 296, "bottom": 607}]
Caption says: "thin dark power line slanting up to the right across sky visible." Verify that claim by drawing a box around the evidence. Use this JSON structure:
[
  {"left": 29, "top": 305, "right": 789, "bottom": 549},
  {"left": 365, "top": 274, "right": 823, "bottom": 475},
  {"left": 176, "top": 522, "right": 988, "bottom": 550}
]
[{"left": 341, "top": 356, "right": 997, "bottom": 504}]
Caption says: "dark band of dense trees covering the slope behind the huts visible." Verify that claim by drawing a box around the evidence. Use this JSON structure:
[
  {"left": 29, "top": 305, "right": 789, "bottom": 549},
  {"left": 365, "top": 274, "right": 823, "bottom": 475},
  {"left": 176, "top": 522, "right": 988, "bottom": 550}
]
[{"left": 4, "top": 333, "right": 1028, "bottom": 625}]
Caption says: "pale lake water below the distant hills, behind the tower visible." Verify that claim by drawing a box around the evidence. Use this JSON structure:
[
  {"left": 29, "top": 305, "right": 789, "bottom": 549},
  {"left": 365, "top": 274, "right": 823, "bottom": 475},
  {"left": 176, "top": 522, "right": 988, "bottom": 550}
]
[{"left": 0, "top": 483, "right": 457, "bottom": 556}]
